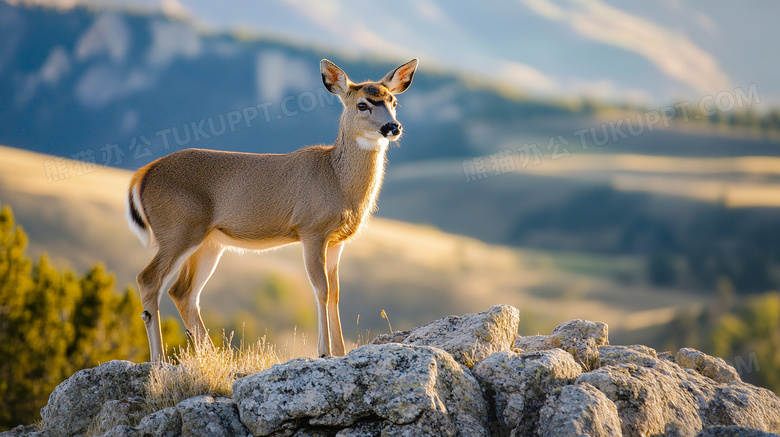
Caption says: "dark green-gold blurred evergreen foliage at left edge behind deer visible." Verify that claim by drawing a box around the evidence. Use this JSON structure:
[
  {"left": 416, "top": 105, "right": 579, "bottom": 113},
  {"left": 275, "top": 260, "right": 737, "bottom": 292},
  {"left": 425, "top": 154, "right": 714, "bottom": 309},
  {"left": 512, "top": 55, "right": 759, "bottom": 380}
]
[{"left": 0, "top": 206, "right": 182, "bottom": 429}]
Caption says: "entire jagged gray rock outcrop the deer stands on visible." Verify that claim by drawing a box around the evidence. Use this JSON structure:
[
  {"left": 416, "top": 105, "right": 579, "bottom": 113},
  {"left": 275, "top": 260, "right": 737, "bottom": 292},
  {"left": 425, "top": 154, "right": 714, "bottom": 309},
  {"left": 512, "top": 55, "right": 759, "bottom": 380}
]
[{"left": 2, "top": 306, "right": 780, "bottom": 437}]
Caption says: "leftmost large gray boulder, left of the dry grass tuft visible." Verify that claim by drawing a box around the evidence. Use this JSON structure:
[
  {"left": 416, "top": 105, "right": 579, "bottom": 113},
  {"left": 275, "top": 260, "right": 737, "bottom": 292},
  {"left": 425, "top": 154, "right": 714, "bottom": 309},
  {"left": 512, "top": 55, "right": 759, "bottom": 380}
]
[{"left": 41, "top": 361, "right": 152, "bottom": 437}]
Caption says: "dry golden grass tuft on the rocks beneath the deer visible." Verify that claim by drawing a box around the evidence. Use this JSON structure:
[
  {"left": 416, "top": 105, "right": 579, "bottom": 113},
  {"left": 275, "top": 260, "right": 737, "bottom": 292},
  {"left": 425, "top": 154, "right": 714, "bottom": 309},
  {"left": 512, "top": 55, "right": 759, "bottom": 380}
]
[{"left": 146, "top": 334, "right": 280, "bottom": 413}]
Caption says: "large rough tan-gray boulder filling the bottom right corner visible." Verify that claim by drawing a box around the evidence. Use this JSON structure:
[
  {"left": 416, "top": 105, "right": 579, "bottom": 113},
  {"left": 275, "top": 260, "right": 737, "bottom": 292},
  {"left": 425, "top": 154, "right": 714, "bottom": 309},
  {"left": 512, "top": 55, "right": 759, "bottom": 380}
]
[{"left": 577, "top": 354, "right": 780, "bottom": 436}]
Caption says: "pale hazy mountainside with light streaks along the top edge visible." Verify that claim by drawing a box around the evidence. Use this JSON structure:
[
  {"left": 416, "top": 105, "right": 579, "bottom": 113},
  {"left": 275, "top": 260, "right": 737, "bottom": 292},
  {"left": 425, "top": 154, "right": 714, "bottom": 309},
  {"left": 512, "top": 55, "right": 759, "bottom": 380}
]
[{"left": 6, "top": 0, "right": 780, "bottom": 105}]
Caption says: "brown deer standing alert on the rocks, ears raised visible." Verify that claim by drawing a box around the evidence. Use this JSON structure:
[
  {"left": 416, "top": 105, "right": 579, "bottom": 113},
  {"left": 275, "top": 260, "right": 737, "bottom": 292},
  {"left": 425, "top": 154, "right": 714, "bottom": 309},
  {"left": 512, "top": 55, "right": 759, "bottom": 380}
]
[{"left": 126, "top": 59, "right": 419, "bottom": 362}]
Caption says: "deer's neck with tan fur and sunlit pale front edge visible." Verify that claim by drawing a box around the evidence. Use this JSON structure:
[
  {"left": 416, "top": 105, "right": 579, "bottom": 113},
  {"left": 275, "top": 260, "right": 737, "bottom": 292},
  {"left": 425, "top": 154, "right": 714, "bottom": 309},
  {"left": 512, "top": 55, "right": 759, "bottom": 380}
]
[{"left": 332, "top": 131, "right": 388, "bottom": 221}]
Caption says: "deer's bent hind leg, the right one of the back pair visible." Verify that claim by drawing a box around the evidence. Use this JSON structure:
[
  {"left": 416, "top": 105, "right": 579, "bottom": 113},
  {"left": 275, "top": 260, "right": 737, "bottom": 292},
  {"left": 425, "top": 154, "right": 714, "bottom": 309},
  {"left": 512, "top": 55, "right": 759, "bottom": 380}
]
[{"left": 168, "top": 241, "right": 223, "bottom": 347}]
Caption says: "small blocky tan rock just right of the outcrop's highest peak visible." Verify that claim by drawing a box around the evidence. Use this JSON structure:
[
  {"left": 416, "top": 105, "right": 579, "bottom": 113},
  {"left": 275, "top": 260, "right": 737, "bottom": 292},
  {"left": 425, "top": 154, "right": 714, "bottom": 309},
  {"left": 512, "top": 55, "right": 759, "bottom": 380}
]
[{"left": 515, "top": 319, "right": 609, "bottom": 370}]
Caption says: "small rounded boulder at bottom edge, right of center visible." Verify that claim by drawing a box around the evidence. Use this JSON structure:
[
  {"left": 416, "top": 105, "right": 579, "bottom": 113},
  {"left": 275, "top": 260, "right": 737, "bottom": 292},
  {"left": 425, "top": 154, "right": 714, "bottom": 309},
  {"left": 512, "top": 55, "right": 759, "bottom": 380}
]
[{"left": 537, "top": 384, "right": 621, "bottom": 437}]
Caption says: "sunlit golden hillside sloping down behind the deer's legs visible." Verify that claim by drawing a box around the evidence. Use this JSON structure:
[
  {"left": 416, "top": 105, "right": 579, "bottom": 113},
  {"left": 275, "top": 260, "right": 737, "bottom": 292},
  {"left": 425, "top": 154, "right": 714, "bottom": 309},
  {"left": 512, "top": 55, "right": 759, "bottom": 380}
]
[{"left": 0, "top": 147, "right": 706, "bottom": 347}]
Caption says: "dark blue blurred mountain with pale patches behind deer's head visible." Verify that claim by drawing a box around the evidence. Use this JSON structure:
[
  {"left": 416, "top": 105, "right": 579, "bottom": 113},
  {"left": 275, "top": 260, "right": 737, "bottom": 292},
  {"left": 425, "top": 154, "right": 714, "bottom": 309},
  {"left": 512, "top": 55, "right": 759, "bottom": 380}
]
[{"left": 0, "top": 3, "right": 596, "bottom": 168}]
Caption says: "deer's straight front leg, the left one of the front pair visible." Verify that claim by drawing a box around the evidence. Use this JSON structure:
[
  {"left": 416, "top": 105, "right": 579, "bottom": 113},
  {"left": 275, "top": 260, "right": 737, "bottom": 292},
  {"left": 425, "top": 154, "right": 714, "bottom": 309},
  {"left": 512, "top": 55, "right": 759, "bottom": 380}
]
[{"left": 301, "top": 237, "right": 330, "bottom": 357}]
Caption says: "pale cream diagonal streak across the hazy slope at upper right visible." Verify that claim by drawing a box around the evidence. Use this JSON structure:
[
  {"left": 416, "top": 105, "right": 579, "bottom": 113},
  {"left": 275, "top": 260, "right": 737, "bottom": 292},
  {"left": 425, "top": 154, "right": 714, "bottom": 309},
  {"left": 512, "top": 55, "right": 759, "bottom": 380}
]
[{"left": 520, "top": 0, "right": 732, "bottom": 94}]
